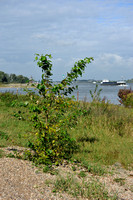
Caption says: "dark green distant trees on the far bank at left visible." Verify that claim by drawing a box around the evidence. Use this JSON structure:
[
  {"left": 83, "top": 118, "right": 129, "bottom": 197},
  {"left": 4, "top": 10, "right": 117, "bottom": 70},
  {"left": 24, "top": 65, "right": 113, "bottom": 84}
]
[{"left": 0, "top": 71, "right": 29, "bottom": 83}]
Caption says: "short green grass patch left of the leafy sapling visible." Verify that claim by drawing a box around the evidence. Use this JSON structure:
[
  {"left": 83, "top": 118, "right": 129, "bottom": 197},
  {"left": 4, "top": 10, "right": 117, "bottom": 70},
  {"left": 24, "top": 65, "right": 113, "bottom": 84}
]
[{"left": 0, "top": 93, "right": 34, "bottom": 147}]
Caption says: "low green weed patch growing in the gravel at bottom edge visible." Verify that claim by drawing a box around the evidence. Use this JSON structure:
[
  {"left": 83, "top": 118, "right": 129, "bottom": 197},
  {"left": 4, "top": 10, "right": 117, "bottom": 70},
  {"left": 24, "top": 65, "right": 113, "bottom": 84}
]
[{"left": 53, "top": 174, "right": 117, "bottom": 200}]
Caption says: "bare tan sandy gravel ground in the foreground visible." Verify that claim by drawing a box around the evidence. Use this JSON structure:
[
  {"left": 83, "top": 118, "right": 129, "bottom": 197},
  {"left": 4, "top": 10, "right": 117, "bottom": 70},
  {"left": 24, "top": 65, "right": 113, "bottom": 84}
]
[{"left": 0, "top": 147, "right": 133, "bottom": 200}]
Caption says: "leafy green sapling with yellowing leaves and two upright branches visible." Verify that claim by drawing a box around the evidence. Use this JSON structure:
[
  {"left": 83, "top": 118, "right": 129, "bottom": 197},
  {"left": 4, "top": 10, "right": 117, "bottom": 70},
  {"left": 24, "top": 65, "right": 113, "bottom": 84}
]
[{"left": 25, "top": 54, "right": 93, "bottom": 164}]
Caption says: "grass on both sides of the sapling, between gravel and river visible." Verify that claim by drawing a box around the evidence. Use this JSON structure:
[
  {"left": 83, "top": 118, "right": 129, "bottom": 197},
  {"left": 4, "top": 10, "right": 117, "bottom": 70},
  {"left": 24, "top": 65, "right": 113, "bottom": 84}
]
[{"left": 0, "top": 93, "right": 133, "bottom": 171}]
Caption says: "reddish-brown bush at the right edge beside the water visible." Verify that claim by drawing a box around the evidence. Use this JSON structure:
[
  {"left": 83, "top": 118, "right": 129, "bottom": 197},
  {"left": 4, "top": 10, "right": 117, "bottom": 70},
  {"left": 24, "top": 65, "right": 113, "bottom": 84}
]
[{"left": 118, "top": 88, "right": 133, "bottom": 107}]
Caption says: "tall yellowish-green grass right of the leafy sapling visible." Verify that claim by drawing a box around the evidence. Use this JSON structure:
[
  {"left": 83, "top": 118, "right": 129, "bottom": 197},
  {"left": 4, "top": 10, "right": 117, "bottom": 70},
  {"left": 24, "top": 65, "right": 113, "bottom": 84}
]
[{"left": 71, "top": 102, "right": 133, "bottom": 167}]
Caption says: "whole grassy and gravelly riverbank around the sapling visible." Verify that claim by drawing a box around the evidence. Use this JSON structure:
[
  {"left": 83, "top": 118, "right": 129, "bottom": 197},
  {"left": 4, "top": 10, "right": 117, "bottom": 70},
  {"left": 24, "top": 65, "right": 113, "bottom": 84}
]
[{"left": 0, "top": 93, "right": 133, "bottom": 200}]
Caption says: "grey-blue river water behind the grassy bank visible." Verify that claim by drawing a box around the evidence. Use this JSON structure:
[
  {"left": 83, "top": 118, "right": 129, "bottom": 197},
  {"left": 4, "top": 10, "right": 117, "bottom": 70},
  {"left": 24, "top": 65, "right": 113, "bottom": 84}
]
[{"left": 0, "top": 82, "right": 133, "bottom": 104}]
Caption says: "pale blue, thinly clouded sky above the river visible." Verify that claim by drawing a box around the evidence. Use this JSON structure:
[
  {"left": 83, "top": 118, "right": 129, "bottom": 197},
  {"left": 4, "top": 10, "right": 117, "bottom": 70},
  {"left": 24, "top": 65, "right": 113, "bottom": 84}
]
[{"left": 0, "top": 0, "right": 133, "bottom": 81}]
